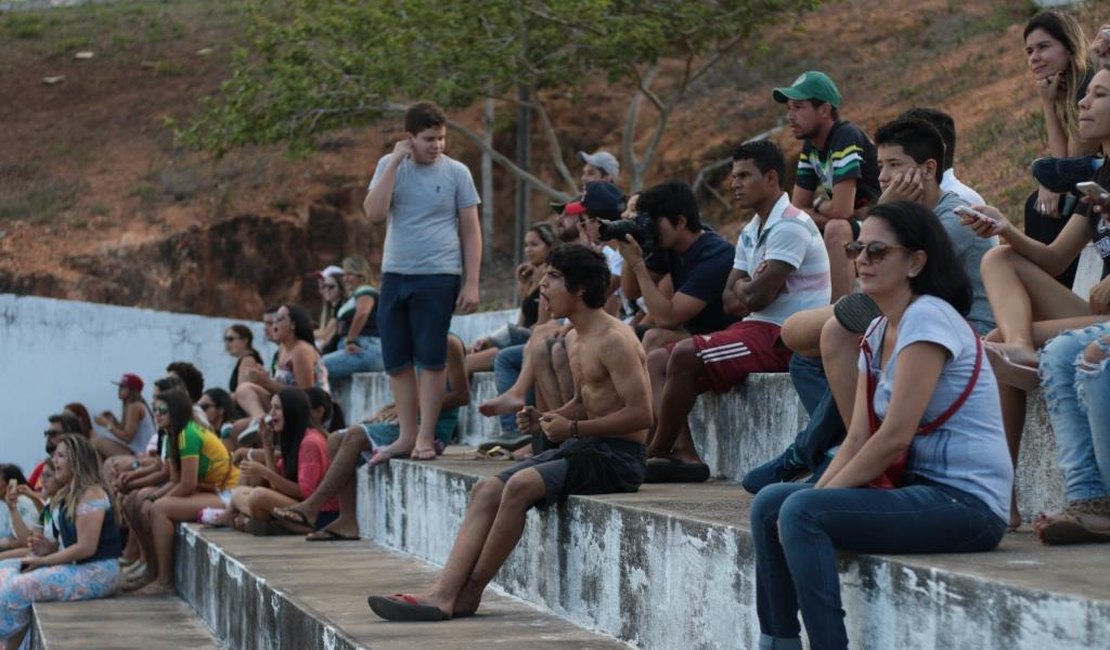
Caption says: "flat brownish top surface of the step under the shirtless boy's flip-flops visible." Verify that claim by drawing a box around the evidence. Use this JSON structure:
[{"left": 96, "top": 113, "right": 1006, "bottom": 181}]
[{"left": 185, "top": 527, "right": 628, "bottom": 650}]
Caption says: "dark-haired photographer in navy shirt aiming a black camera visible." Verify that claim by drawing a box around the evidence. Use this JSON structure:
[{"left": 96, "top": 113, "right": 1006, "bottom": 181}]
[{"left": 617, "top": 181, "right": 736, "bottom": 353}]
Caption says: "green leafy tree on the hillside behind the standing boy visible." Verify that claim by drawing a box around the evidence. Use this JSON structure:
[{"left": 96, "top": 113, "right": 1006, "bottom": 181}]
[{"left": 180, "top": 0, "right": 819, "bottom": 199}]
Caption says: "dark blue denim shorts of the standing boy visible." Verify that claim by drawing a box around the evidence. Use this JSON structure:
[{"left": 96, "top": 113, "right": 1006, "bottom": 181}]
[{"left": 377, "top": 273, "right": 462, "bottom": 374}]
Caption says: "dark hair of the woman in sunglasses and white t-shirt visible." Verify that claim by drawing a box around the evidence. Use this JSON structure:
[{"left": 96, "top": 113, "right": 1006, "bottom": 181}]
[{"left": 867, "top": 201, "right": 973, "bottom": 316}]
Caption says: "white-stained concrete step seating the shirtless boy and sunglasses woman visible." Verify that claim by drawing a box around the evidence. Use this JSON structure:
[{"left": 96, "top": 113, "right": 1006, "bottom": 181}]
[{"left": 359, "top": 448, "right": 1110, "bottom": 650}]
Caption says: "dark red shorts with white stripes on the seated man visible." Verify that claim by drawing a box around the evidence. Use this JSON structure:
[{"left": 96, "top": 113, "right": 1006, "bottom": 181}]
[{"left": 693, "top": 321, "right": 791, "bottom": 393}]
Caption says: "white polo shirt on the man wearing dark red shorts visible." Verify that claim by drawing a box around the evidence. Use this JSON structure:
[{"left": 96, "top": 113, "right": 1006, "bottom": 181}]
[{"left": 733, "top": 192, "right": 831, "bottom": 325}]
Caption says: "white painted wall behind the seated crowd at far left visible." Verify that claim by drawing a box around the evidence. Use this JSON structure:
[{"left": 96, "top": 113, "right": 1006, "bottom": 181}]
[{"left": 0, "top": 294, "right": 268, "bottom": 473}]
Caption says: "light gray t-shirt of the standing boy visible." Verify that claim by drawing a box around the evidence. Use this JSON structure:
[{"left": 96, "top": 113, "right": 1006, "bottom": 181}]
[{"left": 370, "top": 153, "right": 482, "bottom": 275}]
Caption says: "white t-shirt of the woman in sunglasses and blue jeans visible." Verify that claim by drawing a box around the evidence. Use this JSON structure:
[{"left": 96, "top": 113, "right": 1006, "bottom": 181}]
[{"left": 859, "top": 295, "right": 1013, "bottom": 521}]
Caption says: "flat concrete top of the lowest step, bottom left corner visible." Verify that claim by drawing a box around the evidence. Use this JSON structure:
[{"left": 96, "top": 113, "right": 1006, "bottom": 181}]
[{"left": 31, "top": 597, "right": 223, "bottom": 650}]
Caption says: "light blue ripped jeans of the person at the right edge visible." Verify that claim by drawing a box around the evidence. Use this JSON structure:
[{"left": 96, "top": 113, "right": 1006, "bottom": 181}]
[{"left": 1040, "top": 322, "right": 1110, "bottom": 501}]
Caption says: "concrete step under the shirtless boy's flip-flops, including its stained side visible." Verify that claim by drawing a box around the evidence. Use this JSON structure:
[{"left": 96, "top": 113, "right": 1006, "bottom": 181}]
[{"left": 175, "top": 525, "right": 627, "bottom": 650}]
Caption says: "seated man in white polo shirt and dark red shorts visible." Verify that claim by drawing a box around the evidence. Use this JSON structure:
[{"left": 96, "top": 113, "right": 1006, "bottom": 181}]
[{"left": 647, "top": 141, "right": 830, "bottom": 483}]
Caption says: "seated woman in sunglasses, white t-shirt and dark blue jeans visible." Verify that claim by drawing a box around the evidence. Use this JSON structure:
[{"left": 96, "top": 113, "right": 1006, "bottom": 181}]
[{"left": 751, "top": 203, "right": 1013, "bottom": 650}]
